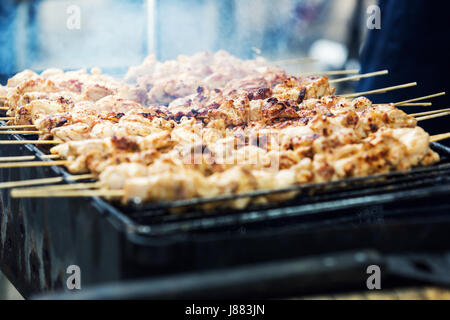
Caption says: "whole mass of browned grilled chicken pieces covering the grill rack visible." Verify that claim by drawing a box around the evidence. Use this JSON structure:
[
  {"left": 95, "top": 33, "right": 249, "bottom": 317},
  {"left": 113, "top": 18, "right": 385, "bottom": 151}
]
[{"left": 0, "top": 52, "right": 439, "bottom": 208}]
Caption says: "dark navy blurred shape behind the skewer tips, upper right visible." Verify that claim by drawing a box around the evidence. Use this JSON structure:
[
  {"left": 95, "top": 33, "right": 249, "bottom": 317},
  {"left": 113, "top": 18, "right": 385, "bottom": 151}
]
[{"left": 356, "top": 0, "right": 450, "bottom": 145}]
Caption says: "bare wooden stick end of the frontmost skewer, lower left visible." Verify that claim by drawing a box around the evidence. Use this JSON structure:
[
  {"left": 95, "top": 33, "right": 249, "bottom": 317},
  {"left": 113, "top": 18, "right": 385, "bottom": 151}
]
[{"left": 11, "top": 189, "right": 125, "bottom": 198}]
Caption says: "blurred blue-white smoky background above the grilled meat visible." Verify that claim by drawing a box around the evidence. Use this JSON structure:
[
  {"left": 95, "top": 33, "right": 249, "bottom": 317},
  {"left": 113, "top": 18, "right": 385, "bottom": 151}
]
[{"left": 0, "top": 0, "right": 375, "bottom": 82}]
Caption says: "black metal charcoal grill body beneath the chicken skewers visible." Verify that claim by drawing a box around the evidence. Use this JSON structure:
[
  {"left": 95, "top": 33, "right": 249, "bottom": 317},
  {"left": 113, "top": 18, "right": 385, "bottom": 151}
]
[{"left": 0, "top": 124, "right": 450, "bottom": 296}]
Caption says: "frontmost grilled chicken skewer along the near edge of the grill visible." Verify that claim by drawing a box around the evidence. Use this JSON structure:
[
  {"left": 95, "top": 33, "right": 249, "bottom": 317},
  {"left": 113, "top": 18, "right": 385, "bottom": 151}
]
[{"left": 15, "top": 128, "right": 438, "bottom": 208}]
